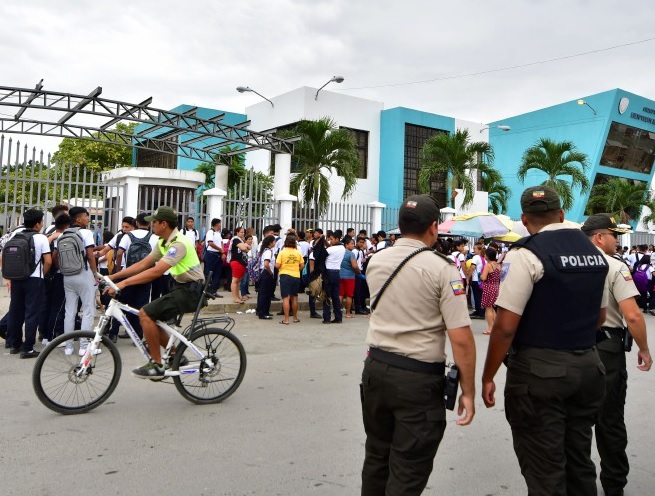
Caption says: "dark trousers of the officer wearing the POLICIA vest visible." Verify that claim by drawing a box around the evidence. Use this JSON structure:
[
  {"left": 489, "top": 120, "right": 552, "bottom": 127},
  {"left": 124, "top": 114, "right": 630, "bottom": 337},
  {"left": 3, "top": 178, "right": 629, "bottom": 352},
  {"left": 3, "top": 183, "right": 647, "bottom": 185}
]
[{"left": 505, "top": 348, "right": 605, "bottom": 496}]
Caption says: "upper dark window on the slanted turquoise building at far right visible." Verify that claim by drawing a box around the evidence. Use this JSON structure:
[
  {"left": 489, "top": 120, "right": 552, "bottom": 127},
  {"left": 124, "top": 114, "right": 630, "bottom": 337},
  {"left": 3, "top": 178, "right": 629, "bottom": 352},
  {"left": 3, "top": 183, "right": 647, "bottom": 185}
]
[{"left": 600, "top": 122, "right": 655, "bottom": 174}]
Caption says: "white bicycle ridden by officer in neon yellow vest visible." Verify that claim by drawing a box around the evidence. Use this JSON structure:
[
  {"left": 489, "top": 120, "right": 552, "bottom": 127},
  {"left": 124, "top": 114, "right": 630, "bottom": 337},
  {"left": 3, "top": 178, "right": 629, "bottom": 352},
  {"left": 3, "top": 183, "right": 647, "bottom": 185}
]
[{"left": 32, "top": 275, "right": 246, "bottom": 415}]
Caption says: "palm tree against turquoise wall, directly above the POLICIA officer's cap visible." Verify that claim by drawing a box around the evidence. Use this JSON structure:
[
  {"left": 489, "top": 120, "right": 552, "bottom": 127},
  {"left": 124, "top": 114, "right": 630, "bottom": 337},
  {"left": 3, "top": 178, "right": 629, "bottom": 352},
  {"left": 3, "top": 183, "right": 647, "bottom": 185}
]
[{"left": 516, "top": 138, "right": 589, "bottom": 210}]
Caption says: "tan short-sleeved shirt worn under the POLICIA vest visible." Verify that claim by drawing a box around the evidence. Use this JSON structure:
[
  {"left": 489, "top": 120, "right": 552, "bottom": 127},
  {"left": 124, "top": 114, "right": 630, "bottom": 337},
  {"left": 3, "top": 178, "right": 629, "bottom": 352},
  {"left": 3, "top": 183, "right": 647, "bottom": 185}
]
[{"left": 496, "top": 223, "right": 609, "bottom": 315}]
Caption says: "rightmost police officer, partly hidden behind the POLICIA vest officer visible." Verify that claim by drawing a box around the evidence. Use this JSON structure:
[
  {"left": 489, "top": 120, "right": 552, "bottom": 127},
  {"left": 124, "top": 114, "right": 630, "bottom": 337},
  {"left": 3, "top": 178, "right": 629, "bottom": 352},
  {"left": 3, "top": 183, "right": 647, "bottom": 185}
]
[{"left": 582, "top": 214, "right": 653, "bottom": 496}]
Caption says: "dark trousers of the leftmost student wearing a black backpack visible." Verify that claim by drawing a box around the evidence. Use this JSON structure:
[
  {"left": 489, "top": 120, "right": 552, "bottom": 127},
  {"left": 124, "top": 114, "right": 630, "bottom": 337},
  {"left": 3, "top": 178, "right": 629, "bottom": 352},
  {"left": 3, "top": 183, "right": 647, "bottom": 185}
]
[{"left": 7, "top": 277, "right": 45, "bottom": 351}]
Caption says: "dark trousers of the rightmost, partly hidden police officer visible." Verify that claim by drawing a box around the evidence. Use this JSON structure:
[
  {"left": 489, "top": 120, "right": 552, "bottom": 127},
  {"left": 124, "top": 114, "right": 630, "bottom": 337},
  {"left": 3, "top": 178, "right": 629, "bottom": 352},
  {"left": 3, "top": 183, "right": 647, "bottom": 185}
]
[{"left": 596, "top": 336, "right": 630, "bottom": 492}]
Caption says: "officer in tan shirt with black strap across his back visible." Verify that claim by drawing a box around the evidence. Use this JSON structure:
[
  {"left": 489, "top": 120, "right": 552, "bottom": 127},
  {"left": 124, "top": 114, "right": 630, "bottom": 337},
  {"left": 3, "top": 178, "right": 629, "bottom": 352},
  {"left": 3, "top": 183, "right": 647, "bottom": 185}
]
[{"left": 361, "top": 195, "right": 475, "bottom": 496}]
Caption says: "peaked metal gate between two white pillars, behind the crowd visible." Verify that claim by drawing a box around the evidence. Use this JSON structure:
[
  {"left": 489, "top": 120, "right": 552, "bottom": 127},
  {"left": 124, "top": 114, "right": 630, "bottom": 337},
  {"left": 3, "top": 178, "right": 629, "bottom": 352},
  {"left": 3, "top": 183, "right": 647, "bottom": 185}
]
[{"left": 223, "top": 169, "right": 278, "bottom": 233}]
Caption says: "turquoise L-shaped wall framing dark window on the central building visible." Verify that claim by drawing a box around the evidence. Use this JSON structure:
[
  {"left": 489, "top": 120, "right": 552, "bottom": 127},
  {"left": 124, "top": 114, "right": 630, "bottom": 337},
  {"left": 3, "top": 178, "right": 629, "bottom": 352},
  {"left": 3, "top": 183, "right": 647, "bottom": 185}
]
[{"left": 379, "top": 107, "right": 455, "bottom": 208}]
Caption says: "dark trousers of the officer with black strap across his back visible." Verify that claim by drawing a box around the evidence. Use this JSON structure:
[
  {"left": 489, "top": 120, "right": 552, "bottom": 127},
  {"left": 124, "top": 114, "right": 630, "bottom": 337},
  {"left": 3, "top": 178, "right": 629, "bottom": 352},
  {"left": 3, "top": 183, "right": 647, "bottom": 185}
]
[{"left": 360, "top": 357, "right": 446, "bottom": 496}]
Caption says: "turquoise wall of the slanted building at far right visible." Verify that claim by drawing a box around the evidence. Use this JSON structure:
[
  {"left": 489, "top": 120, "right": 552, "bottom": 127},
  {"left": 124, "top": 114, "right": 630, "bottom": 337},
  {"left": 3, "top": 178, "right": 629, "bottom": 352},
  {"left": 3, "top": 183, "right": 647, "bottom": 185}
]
[{"left": 489, "top": 89, "right": 655, "bottom": 222}]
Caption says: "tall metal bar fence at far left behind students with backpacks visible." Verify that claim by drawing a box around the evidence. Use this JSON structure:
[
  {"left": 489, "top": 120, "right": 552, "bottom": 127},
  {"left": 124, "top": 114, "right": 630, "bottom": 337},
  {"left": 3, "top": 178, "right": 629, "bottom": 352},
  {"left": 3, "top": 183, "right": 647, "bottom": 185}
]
[{"left": 0, "top": 136, "right": 125, "bottom": 231}]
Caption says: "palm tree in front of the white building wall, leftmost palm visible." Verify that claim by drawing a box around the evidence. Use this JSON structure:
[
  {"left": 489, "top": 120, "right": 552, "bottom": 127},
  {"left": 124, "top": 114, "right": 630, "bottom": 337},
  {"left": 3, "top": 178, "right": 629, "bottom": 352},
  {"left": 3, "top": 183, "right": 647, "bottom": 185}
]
[{"left": 285, "top": 117, "right": 360, "bottom": 215}]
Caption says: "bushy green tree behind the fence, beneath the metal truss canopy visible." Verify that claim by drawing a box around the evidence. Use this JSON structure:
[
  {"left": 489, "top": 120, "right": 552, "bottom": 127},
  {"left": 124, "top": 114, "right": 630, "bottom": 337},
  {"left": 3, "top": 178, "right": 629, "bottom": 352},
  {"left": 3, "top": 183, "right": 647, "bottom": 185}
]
[{"left": 53, "top": 122, "right": 137, "bottom": 172}]
